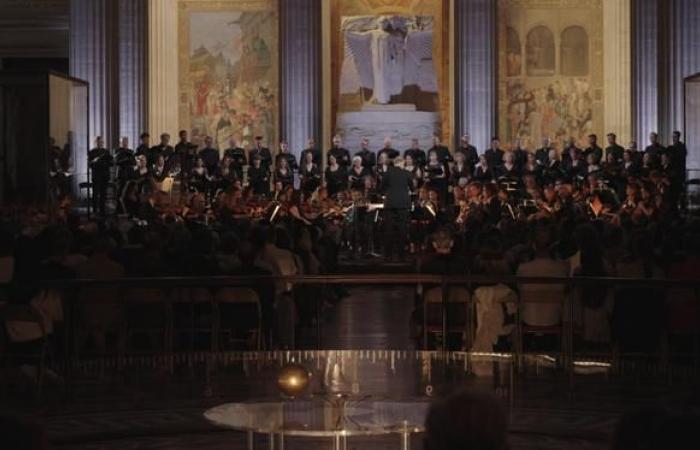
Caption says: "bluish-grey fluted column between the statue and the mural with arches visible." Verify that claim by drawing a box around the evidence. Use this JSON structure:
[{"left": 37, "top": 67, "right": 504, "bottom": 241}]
[{"left": 454, "top": 0, "right": 497, "bottom": 152}]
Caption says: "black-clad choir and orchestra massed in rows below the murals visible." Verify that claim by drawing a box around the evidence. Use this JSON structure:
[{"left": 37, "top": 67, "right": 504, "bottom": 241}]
[{"left": 71, "top": 131, "right": 685, "bottom": 257}]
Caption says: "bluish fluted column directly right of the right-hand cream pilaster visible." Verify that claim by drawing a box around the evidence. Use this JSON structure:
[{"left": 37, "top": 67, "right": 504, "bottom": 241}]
[{"left": 632, "top": 0, "right": 659, "bottom": 148}]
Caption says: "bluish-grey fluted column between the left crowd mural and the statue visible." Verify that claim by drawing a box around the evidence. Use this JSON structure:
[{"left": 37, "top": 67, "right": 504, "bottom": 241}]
[{"left": 280, "top": 0, "right": 323, "bottom": 155}]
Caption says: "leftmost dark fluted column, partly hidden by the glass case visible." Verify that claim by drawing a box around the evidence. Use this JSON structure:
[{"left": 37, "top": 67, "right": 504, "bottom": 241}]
[{"left": 70, "top": 0, "right": 119, "bottom": 145}]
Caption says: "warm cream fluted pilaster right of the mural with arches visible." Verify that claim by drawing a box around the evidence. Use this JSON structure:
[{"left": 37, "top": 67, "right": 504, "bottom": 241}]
[{"left": 603, "top": 0, "right": 632, "bottom": 145}]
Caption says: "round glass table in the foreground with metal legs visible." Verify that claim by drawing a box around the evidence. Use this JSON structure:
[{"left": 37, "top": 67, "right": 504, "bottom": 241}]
[{"left": 204, "top": 394, "right": 430, "bottom": 450}]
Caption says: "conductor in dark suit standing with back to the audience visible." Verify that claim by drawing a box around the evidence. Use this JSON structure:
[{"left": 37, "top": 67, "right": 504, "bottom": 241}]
[{"left": 382, "top": 156, "right": 412, "bottom": 261}]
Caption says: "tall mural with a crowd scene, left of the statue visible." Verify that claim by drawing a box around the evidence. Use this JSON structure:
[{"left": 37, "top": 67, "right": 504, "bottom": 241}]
[{"left": 179, "top": 0, "right": 278, "bottom": 149}]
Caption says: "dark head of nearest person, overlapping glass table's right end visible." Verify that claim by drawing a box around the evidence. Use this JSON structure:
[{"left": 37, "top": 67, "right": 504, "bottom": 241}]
[{"left": 424, "top": 392, "right": 508, "bottom": 450}]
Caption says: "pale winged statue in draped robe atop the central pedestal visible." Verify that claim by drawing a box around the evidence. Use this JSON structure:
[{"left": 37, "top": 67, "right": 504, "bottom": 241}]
[{"left": 341, "top": 16, "right": 437, "bottom": 105}]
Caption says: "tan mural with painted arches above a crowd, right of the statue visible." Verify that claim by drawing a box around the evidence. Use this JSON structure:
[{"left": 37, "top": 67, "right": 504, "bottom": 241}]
[{"left": 499, "top": 0, "right": 604, "bottom": 148}]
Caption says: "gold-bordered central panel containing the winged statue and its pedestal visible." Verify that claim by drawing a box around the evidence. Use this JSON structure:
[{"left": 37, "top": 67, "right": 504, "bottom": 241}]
[{"left": 326, "top": 0, "right": 450, "bottom": 150}]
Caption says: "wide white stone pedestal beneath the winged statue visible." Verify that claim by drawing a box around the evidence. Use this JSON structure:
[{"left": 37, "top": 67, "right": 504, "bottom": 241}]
[{"left": 336, "top": 110, "right": 440, "bottom": 153}]
